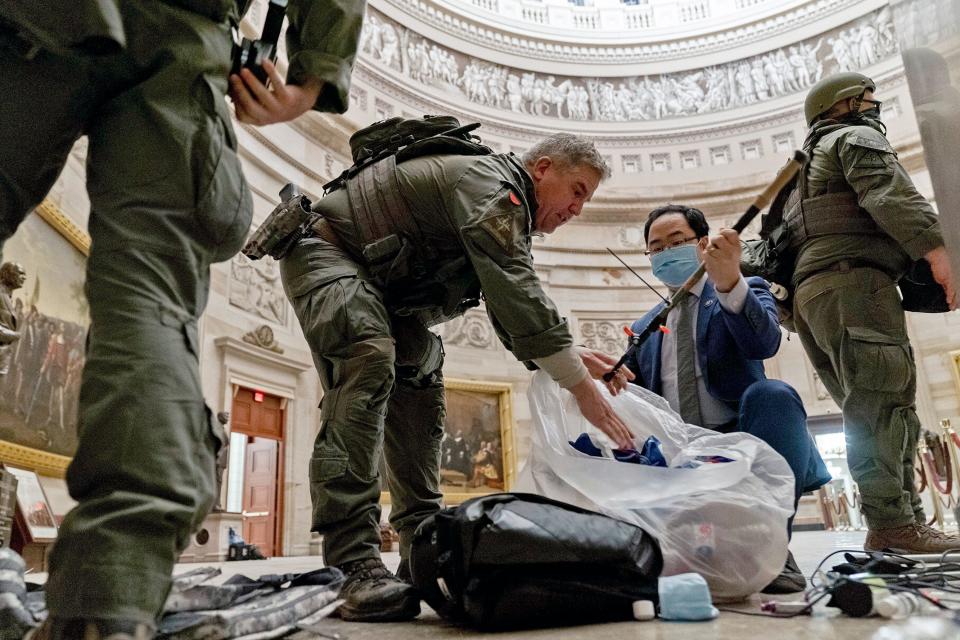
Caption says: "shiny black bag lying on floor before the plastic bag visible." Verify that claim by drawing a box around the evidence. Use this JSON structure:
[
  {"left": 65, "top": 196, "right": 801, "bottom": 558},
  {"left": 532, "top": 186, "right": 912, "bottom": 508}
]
[{"left": 410, "top": 493, "right": 663, "bottom": 630}]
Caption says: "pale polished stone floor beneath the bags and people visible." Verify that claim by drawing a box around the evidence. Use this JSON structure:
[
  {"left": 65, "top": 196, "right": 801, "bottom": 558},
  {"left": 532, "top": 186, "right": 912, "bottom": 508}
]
[{"left": 172, "top": 532, "right": 960, "bottom": 640}]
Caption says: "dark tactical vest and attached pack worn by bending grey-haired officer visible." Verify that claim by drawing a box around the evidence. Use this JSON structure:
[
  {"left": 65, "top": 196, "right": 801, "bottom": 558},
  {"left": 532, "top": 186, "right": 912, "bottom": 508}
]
[{"left": 324, "top": 116, "right": 493, "bottom": 326}]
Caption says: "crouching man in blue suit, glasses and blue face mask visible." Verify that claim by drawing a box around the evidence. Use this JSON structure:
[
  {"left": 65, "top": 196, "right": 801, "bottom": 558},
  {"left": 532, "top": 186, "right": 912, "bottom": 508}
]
[{"left": 630, "top": 204, "right": 830, "bottom": 593}]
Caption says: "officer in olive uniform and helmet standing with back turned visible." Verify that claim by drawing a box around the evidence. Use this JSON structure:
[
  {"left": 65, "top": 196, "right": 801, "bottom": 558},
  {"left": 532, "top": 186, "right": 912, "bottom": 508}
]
[{"left": 784, "top": 73, "right": 960, "bottom": 553}]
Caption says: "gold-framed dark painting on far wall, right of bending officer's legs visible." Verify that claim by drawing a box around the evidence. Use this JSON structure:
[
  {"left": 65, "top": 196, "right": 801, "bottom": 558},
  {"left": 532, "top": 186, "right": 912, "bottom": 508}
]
[{"left": 381, "top": 379, "right": 517, "bottom": 505}]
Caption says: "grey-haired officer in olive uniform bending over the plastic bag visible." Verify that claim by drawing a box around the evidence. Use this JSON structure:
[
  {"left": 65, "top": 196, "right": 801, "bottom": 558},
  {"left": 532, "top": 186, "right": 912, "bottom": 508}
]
[{"left": 281, "top": 135, "right": 629, "bottom": 621}]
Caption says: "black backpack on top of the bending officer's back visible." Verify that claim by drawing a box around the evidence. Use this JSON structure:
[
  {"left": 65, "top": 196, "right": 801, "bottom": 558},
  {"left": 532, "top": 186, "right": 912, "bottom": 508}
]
[{"left": 323, "top": 116, "right": 493, "bottom": 193}]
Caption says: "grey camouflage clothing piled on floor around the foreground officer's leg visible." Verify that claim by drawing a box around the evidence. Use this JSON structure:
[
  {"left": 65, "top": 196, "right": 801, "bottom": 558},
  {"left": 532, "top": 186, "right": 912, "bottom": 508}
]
[{"left": 0, "top": 549, "right": 344, "bottom": 640}]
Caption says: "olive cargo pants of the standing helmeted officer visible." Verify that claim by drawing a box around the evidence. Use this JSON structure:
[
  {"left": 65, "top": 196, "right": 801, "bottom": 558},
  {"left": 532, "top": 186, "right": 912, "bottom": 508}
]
[{"left": 794, "top": 268, "right": 923, "bottom": 529}]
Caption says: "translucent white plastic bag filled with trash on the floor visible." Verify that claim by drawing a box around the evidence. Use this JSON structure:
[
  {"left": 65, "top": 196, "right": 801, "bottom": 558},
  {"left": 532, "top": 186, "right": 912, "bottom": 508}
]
[{"left": 514, "top": 371, "right": 794, "bottom": 599}]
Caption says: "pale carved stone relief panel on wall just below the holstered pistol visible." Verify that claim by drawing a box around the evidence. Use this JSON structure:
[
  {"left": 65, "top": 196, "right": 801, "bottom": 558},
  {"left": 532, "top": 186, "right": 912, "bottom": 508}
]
[{"left": 229, "top": 253, "right": 290, "bottom": 326}]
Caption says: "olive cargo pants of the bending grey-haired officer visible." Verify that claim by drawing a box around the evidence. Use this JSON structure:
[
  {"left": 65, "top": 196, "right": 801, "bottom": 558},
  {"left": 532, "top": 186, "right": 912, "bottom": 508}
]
[{"left": 281, "top": 238, "right": 445, "bottom": 566}]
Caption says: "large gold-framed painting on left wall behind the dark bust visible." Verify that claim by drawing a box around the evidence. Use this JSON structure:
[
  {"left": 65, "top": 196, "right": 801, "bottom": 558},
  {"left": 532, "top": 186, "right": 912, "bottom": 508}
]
[{"left": 0, "top": 201, "right": 90, "bottom": 476}]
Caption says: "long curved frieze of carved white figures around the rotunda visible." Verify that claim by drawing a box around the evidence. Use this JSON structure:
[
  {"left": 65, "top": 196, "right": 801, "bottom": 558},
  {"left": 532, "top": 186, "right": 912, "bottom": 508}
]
[{"left": 360, "top": 7, "right": 898, "bottom": 122}]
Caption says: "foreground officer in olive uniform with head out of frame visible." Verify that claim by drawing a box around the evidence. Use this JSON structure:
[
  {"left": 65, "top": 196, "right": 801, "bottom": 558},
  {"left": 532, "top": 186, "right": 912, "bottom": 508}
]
[{"left": 0, "top": 0, "right": 364, "bottom": 639}]
